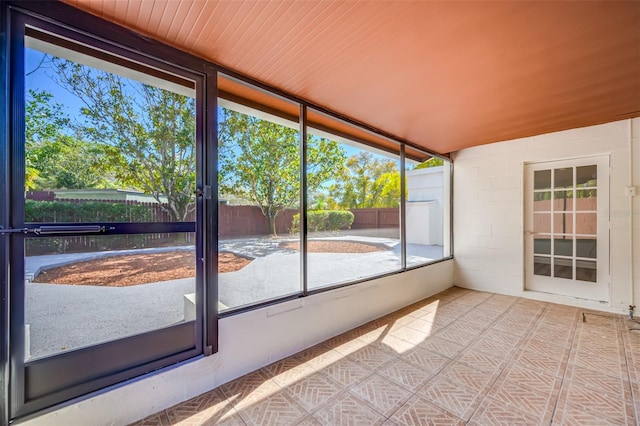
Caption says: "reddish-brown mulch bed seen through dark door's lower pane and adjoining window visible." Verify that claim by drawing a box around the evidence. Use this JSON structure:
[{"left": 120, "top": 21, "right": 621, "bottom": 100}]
[{"left": 33, "top": 251, "right": 251, "bottom": 287}]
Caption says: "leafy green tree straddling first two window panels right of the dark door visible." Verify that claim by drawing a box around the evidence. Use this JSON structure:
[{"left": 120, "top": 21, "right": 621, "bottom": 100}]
[{"left": 218, "top": 108, "right": 345, "bottom": 235}]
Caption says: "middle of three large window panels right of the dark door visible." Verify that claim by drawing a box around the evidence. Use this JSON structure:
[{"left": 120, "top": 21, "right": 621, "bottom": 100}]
[{"left": 306, "top": 111, "right": 402, "bottom": 290}]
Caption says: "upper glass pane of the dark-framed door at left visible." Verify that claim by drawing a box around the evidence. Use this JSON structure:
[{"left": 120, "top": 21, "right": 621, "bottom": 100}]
[{"left": 25, "top": 37, "right": 196, "bottom": 223}]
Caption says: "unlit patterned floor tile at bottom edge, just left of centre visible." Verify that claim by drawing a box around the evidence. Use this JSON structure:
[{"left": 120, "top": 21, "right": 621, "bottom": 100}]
[{"left": 238, "top": 391, "right": 308, "bottom": 426}]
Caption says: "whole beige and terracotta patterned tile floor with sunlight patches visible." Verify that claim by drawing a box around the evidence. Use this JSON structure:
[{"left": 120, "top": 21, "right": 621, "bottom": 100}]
[{"left": 130, "top": 287, "right": 640, "bottom": 426}]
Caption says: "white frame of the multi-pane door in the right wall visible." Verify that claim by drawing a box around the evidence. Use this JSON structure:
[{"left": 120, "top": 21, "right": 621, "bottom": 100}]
[{"left": 522, "top": 154, "right": 611, "bottom": 303}]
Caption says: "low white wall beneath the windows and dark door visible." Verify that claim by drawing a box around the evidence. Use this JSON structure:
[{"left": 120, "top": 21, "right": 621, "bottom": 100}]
[{"left": 20, "top": 261, "right": 453, "bottom": 426}]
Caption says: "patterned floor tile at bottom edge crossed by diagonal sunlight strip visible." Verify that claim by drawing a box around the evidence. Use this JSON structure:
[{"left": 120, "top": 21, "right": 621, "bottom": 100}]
[{"left": 166, "top": 389, "right": 244, "bottom": 426}]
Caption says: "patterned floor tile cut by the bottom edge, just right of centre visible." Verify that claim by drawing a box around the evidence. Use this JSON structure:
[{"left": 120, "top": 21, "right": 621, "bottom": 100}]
[{"left": 313, "top": 391, "right": 386, "bottom": 426}]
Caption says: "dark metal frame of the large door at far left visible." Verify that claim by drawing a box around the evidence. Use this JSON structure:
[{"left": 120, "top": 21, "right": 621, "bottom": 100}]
[{"left": 0, "top": 2, "right": 217, "bottom": 424}]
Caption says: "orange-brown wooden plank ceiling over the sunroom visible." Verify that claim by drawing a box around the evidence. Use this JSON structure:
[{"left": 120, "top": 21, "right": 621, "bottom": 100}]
[{"left": 66, "top": 0, "right": 640, "bottom": 153}]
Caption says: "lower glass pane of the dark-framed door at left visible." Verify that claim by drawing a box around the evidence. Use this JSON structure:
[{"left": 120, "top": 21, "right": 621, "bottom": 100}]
[{"left": 24, "top": 233, "right": 196, "bottom": 360}]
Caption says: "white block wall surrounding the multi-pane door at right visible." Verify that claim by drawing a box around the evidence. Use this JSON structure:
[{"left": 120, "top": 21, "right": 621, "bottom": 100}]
[{"left": 453, "top": 119, "right": 640, "bottom": 312}]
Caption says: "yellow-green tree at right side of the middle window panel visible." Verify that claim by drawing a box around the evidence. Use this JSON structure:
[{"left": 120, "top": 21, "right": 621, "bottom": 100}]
[{"left": 330, "top": 151, "right": 400, "bottom": 209}]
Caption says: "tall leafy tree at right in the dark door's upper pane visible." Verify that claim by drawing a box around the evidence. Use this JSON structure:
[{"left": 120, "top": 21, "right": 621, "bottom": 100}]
[{"left": 52, "top": 59, "right": 196, "bottom": 221}]
